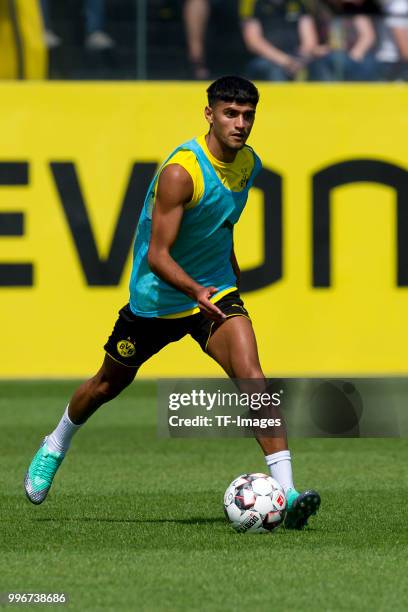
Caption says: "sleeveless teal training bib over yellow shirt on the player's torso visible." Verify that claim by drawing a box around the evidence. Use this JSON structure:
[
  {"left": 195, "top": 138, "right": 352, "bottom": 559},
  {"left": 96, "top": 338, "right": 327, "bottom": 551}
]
[{"left": 129, "top": 137, "right": 261, "bottom": 317}]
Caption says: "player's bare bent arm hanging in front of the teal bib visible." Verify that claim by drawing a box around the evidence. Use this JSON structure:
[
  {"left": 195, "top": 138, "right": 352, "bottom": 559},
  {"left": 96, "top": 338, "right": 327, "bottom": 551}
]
[{"left": 147, "top": 164, "right": 225, "bottom": 320}]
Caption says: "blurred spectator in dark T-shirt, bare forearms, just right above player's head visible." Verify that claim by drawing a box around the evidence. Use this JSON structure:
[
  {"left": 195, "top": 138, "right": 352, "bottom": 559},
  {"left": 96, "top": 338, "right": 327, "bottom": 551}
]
[{"left": 242, "top": 0, "right": 326, "bottom": 81}]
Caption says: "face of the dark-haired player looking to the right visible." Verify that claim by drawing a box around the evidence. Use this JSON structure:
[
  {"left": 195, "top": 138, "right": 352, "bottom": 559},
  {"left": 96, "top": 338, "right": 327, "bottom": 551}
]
[{"left": 205, "top": 101, "right": 256, "bottom": 150}]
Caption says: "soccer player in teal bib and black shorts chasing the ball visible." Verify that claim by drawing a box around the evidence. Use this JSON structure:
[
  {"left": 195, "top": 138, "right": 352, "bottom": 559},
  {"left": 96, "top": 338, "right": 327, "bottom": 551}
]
[{"left": 24, "top": 76, "right": 320, "bottom": 529}]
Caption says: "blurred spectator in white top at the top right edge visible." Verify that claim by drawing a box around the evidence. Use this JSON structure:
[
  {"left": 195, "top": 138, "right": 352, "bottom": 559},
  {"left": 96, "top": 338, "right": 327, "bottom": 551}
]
[{"left": 377, "top": 0, "right": 408, "bottom": 81}]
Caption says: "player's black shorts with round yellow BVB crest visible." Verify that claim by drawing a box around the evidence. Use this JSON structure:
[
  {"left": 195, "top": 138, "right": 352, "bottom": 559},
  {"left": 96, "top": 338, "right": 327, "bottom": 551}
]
[{"left": 104, "top": 291, "right": 249, "bottom": 368}]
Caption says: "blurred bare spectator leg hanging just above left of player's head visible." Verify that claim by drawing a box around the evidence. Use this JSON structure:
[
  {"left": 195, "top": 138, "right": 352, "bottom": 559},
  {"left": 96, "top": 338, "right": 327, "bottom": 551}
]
[{"left": 183, "top": 0, "right": 210, "bottom": 79}]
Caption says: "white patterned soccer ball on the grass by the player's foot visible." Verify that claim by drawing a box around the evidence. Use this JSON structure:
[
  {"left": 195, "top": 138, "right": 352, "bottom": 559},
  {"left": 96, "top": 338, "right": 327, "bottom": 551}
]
[{"left": 224, "top": 474, "right": 286, "bottom": 533}]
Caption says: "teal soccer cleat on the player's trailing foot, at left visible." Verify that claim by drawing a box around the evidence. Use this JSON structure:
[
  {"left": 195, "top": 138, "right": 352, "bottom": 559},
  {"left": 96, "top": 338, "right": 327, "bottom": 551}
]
[{"left": 24, "top": 438, "right": 65, "bottom": 504}]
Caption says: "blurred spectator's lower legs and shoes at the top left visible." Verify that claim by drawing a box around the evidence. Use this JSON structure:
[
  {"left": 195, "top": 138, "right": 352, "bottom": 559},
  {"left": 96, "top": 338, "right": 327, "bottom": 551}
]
[{"left": 41, "top": 0, "right": 115, "bottom": 51}]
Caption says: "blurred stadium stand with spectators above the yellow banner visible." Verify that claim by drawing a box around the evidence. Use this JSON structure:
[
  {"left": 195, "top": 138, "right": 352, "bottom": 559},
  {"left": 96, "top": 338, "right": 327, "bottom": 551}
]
[{"left": 0, "top": 0, "right": 408, "bottom": 81}]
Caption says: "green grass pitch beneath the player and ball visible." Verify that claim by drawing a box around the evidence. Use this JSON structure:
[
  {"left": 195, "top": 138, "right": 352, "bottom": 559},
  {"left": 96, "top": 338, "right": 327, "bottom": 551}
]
[{"left": 0, "top": 381, "right": 408, "bottom": 612}]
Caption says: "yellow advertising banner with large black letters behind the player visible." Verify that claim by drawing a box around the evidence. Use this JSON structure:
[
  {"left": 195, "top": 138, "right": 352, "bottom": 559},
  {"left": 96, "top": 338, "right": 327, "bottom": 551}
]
[{"left": 0, "top": 83, "right": 408, "bottom": 378}]
